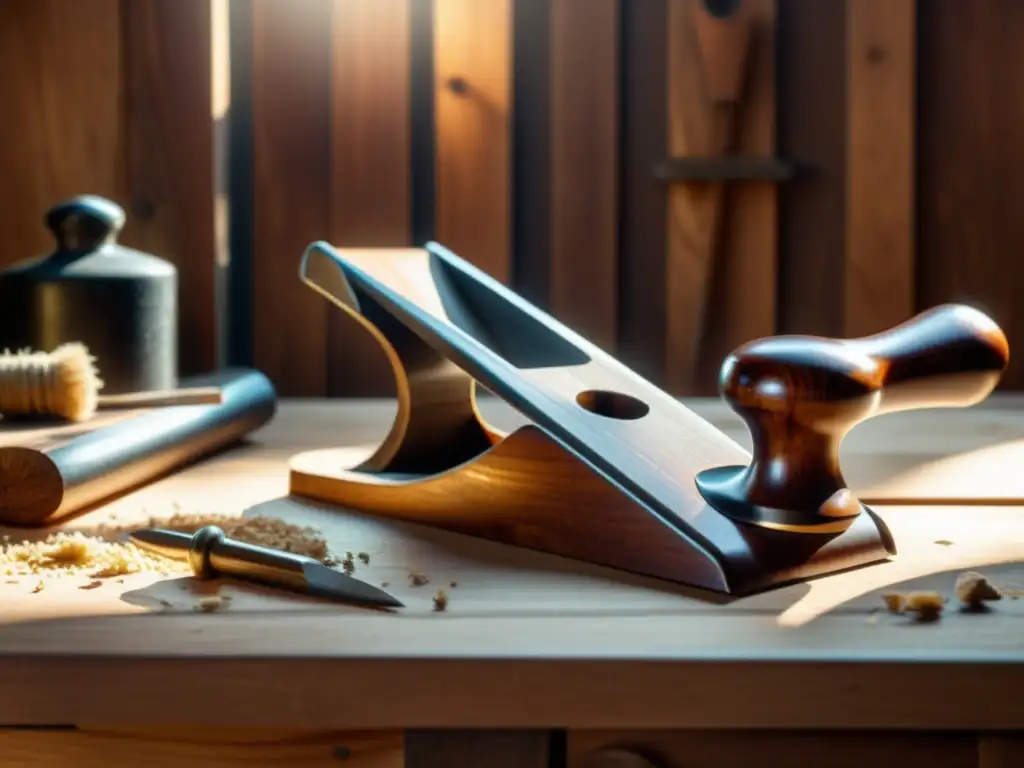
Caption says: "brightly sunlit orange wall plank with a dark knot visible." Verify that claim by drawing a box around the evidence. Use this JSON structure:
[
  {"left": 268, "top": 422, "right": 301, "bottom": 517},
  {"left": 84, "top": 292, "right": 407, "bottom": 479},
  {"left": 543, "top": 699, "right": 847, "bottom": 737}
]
[{"left": 433, "top": 0, "right": 512, "bottom": 283}]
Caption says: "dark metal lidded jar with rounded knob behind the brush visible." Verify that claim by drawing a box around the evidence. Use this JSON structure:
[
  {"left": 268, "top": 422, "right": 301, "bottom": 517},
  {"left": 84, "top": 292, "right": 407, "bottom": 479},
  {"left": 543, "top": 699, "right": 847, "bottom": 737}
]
[{"left": 0, "top": 196, "right": 178, "bottom": 394}]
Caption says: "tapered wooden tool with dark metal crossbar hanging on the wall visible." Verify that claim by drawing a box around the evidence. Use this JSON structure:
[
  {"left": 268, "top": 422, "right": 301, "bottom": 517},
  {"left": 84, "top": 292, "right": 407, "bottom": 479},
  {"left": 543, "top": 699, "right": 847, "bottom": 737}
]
[{"left": 654, "top": 0, "right": 792, "bottom": 393}]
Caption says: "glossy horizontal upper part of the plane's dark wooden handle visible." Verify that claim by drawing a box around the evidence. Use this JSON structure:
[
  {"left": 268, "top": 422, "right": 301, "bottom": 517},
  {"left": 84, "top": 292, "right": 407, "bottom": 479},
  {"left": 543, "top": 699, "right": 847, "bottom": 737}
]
[{"left": 721, "top": 305, "right": 1010, "bottom": 434}]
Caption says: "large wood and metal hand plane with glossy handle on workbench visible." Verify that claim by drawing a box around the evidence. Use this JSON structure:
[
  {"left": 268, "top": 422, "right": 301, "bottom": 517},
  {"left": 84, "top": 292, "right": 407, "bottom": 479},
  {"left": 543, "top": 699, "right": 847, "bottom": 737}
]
[{"left": 290, "top": 243, "right": 1009, "bottom": 594}]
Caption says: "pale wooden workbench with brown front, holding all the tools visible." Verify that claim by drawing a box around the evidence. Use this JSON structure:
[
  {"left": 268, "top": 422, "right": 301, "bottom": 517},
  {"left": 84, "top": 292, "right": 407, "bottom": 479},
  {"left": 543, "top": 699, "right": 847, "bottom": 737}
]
[{"left": 0, "top": 396, "right": 1024, "bottom": 768}]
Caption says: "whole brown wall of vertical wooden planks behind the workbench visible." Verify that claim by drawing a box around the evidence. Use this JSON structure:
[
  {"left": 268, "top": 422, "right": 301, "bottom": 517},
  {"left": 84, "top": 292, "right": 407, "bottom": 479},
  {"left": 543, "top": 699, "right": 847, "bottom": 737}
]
[{"left": 6, "top": 0, "right": 1024, "bottom": 396}]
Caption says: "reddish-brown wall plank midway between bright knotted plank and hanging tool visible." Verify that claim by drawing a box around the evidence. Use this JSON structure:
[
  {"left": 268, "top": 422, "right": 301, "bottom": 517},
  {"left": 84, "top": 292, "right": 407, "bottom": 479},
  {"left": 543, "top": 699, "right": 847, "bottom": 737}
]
[{"left": 550, "top": 0, "right": 621, "bottom": 351}]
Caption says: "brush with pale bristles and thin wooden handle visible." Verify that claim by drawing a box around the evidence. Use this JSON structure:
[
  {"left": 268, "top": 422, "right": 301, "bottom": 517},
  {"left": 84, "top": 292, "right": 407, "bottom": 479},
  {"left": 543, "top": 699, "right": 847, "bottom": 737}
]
[{"left": 0, "top": 343, "right": 222, "bottom": 422}]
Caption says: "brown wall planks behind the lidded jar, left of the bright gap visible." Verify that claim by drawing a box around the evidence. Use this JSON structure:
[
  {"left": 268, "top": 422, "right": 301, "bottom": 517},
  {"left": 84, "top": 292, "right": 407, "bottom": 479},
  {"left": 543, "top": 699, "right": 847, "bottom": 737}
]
[{"left": 0, "top": 0, "right": 220, "bottom": 374}]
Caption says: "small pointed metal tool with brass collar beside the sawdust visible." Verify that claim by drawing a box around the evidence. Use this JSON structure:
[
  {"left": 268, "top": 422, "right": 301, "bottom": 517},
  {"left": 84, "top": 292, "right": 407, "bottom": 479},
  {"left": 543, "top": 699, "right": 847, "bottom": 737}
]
[{"left": 130, "top": 525, "right": 403, "bottom": 608}]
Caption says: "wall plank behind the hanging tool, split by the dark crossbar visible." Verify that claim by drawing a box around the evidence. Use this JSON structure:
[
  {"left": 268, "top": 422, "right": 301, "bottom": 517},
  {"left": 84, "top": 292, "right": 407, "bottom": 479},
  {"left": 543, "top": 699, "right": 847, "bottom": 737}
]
[{"left": 666, "top": 0, "right": 775, "bottom": 394}]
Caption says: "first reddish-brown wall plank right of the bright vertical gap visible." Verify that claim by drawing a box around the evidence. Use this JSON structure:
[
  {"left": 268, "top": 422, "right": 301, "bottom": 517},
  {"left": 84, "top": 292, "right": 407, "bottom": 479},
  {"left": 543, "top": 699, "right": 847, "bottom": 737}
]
[{"left": 252, "top": 0, "right": 333, "bottom": 396}]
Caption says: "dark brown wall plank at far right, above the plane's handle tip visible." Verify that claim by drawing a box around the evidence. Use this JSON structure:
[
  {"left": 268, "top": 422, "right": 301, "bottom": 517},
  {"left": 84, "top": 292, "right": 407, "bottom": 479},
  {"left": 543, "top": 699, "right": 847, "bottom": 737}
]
[{"left": 916, "top": 0, "right": 1024, "bottom": 389}]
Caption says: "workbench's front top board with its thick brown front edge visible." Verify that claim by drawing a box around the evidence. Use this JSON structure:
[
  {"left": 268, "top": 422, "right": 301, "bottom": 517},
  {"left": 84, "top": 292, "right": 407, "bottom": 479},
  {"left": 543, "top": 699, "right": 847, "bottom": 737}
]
[{"left": 0, "top": 403, "right": 1024, "bottom": 729}]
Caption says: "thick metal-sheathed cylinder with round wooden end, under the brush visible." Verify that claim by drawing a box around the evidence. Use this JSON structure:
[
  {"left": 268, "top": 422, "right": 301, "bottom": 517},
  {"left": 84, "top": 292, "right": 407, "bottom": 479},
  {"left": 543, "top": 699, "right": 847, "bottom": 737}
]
[{"left": 0, "top": 369, "right": 276, "bottom": 525}]
